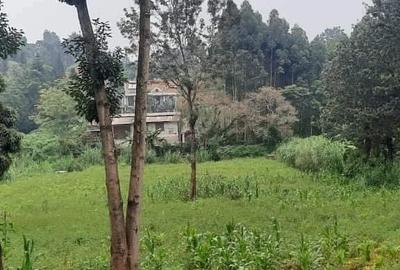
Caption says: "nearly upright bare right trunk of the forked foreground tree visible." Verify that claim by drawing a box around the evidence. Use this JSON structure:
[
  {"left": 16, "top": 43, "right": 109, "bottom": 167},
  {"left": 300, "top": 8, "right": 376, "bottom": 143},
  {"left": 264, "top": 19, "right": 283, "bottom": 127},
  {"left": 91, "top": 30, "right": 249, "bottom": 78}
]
[{"left": 126, "top": 0, "right": 151, "bottom": 270}]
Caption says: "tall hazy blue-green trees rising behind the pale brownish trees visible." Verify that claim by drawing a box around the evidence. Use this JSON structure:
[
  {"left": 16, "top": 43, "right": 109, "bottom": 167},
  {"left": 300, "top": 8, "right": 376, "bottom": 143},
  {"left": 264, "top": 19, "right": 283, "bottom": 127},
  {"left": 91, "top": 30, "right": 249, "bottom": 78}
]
[{"left": 211, "top": 1, "right": 347, "bottom": 97}]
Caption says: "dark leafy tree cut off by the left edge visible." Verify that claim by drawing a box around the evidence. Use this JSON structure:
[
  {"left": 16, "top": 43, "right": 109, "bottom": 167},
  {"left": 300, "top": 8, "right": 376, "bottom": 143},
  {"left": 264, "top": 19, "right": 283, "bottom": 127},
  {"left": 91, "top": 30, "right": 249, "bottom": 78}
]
[{"left": 0, "top": 1, "right": 23, "bottom": 181}]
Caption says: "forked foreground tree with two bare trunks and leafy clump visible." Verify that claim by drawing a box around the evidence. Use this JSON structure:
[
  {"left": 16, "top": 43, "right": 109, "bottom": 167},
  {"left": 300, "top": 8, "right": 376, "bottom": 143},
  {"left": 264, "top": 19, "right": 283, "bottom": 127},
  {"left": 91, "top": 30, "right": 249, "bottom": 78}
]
[{"left": 63, "top": 0, "right": 151, "bottom": 270}]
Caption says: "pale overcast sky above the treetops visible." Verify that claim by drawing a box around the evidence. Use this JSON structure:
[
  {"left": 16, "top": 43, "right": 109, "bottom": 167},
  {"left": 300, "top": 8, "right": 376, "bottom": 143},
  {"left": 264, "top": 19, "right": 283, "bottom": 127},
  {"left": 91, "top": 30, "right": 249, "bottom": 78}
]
[{"left": 4, "top": 0, "right": 371, "bottom": 46}]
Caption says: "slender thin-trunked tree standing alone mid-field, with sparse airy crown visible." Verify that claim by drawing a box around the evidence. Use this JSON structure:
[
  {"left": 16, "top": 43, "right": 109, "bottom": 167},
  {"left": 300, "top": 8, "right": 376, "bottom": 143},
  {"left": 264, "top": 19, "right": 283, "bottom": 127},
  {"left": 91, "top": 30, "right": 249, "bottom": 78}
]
[{"left": 120, "top": 0, "right": 227, "bottom": 199}]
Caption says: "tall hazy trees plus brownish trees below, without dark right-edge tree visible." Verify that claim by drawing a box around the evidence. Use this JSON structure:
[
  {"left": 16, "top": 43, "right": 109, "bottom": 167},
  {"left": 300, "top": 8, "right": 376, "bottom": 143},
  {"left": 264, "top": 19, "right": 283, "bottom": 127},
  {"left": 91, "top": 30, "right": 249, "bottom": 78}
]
[{"left": 170, "top": 0, "right": 348, "bottom": 148}]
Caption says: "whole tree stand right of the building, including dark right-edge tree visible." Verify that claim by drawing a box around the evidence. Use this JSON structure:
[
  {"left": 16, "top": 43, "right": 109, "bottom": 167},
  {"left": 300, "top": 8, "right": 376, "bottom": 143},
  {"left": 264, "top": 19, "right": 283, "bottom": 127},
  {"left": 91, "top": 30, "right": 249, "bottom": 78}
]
[{"left": 184, "top": 0, "right": 400, "bottom": 160}]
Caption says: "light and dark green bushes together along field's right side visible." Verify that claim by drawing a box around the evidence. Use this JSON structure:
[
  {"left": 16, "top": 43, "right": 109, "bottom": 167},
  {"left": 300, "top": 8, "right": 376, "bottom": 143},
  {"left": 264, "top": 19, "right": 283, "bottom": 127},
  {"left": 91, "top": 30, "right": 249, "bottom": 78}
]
[{"left": 276, "top": 136, "right": 400, "bottom": 187}]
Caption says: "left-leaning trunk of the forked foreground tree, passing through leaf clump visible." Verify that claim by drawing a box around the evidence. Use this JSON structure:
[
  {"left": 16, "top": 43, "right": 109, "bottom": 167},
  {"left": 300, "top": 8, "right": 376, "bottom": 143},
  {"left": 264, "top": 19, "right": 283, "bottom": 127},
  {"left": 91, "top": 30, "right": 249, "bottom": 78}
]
[{"left": 75, "top": 0, "right": 128, "bottom": 270}]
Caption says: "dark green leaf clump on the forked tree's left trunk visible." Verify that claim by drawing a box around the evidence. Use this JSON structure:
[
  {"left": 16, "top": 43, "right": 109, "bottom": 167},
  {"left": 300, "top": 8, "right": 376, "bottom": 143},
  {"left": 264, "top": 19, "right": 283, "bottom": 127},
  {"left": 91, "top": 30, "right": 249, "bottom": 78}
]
[{"left": 63, "top": 19, "right": 125, "bottom": 122}]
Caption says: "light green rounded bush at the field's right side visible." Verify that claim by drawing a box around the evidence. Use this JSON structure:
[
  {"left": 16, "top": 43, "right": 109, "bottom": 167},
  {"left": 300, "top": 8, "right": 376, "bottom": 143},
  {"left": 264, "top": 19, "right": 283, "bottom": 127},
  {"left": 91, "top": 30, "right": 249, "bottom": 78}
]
[{"left": 276, "top": 136, "right": 348, "bottom": 173}]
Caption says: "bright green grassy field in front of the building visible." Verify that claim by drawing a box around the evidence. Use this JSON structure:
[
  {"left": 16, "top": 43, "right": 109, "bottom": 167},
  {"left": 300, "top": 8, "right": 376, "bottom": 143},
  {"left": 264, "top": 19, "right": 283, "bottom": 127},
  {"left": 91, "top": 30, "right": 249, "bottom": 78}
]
[{"left": 0, "top": 158, "right": 400, "bottom": 270}]
